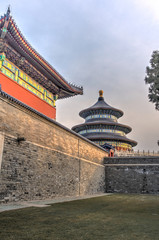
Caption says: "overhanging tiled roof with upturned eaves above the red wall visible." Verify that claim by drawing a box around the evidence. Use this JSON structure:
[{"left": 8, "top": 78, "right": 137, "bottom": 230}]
[{"left": 0, "top": 6, "right": 83, "bottom": 99}]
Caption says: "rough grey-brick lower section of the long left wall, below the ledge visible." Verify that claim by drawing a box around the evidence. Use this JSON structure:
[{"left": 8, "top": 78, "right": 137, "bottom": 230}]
[{"left": 0, "top": 136, "right": 105, "bottom": 202}]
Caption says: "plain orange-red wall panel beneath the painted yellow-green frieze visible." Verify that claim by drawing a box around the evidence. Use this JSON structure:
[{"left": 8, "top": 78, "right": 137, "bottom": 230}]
[{"left": 0, "top": 72, "right": 56, "bottom": 119}]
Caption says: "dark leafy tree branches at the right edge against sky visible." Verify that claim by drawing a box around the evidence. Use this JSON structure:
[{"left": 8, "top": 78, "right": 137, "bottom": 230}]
[{"left": 145, "top": 51, "right": 159, "bottom": 110}]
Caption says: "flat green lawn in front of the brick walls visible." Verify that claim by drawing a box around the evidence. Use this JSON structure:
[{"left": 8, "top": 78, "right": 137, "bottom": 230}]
[{"left": 0, "top": 194, "right": 159, "bottom": 240}]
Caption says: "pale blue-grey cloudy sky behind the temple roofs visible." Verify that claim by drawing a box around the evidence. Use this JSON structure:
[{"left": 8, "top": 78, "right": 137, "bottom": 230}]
[{"left": 0, "top": 0, "right": 159, "bottom": 151}]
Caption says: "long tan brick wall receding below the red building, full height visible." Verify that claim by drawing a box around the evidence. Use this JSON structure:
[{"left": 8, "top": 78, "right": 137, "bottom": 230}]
[{"left": 0, "top": 94, "right": 108, "bottom": 202}]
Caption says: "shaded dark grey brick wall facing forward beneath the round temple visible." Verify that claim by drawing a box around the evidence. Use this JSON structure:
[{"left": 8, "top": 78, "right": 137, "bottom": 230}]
[{"left": 105, "top": 157, "right": 159, "bottom": 194}]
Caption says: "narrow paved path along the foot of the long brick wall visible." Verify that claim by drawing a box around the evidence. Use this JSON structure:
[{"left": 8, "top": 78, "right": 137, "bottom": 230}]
[{"left": 0, "top": 193, "right": 110, "bottom": 212}]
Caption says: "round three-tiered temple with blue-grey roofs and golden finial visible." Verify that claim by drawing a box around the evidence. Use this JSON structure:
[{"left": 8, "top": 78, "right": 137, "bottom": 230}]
[{"left": 72, "top": 90, "right": 137, "bottom": 151}]
